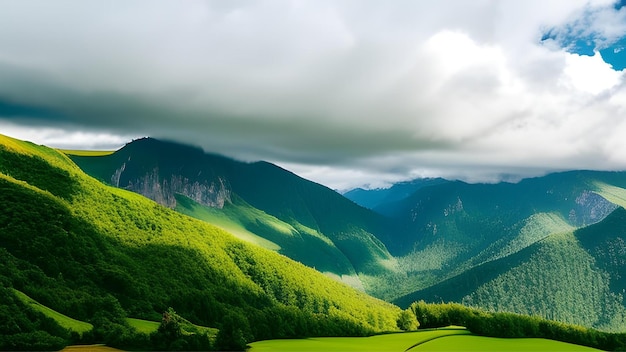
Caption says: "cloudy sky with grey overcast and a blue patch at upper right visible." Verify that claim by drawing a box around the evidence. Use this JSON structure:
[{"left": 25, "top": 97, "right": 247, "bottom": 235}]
[{"left": 0, "top": 0, "right": 626, "bottom": 189}]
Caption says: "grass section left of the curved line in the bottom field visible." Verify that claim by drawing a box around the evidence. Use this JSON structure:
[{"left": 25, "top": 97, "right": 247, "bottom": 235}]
[{"left": 248, "top": 328, "right": 470, "bottom": 352}]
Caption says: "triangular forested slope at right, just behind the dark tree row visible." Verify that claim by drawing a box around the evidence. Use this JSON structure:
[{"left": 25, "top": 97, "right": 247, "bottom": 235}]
[{"left": 397, "top": 207, "right": 626, "bottom": 332}]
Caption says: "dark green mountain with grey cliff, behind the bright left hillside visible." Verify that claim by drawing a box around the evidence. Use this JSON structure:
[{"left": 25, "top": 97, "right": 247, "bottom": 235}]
[{"left": 71, "top": 138, "right": 397, "bottom": 291}]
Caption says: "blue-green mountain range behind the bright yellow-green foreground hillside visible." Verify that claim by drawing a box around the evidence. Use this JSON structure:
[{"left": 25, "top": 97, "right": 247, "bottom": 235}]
[{"left": 72, "top": 138, "right": 626, "bottom": 331}]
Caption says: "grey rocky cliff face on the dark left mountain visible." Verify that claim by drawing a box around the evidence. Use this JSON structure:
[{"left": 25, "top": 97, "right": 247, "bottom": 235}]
[{"left": 111, "top": 163, "right": 231, "bottom": 209}]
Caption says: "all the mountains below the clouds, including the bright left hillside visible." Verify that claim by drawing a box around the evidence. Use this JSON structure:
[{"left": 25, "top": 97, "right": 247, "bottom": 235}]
[{"left": 0, "top": 133, "right": 626, "bottom": 344}]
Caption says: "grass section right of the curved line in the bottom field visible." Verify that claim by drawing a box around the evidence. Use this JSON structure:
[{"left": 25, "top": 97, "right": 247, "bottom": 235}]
[{"left": 410, "top": 335, "right": 600, "bottom": 352}]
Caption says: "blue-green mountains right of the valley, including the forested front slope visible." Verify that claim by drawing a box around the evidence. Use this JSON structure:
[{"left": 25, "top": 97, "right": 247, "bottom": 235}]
[{"left": 381, "top": 171, "right": 626, "bottom": 330}]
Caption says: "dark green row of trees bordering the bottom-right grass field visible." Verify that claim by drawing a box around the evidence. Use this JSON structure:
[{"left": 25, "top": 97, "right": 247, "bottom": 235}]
[{"left": 409, "top": 301, "right": 626, "bottom": 351}]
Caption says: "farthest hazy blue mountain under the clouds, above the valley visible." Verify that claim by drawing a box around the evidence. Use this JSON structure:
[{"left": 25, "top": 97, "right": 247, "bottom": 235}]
[{"left": 343, "top": 178, "right": 449, "bottom": 211}]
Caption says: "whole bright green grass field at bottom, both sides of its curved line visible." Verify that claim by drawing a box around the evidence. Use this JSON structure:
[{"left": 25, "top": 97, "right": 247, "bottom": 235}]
[{"left": 248, "top": 327, "right": 598, "bottom": 352}]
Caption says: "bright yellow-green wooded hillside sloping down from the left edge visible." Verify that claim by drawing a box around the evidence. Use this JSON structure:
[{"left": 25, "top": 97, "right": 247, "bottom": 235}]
[{"left": 0, "top": 135, "right": 400, "bottom": 346}]
